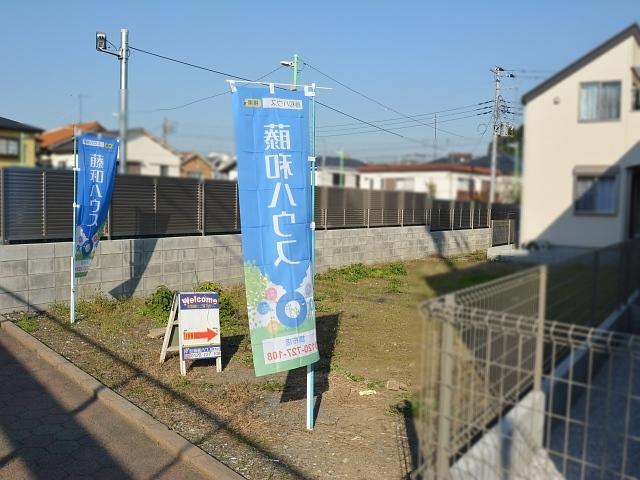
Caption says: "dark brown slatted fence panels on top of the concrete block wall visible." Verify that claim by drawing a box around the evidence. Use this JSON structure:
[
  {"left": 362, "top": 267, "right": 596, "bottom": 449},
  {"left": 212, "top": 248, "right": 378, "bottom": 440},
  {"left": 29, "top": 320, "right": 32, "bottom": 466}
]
[{"left": 0, "top": 168, "right": 518, "bottom": 243}]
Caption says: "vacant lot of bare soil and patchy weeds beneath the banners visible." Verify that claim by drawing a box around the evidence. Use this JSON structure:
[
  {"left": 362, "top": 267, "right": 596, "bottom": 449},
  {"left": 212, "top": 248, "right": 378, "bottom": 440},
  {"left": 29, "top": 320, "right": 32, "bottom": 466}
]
[{"left": 7, "top": 256, "right": 517, "bottom": 479}]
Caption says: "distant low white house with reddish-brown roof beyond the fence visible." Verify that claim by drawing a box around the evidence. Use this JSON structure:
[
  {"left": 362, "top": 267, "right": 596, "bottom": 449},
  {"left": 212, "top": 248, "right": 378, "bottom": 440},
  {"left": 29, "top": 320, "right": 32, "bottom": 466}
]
[{"left": 358, "top": 163, "right": 512, "bottom": 201}]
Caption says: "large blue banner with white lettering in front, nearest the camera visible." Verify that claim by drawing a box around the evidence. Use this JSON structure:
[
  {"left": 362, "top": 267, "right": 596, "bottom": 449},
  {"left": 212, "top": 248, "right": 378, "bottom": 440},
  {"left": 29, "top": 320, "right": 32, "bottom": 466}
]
[{"left": 233, "top": 86, "right": 319, "bottom": 376}]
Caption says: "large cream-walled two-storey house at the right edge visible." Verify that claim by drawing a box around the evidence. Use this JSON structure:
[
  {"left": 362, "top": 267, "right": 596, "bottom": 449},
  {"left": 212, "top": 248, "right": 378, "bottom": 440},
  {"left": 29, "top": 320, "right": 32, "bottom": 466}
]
[{"left": 520, "top": 24, "right": 640, "bottom": 247}]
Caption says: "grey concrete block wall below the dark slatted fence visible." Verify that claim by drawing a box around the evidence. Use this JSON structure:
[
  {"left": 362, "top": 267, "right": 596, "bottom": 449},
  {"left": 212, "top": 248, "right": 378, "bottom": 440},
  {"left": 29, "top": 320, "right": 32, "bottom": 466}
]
[{"left": 0, "top": 226, "right": 491, "bottom": 313}]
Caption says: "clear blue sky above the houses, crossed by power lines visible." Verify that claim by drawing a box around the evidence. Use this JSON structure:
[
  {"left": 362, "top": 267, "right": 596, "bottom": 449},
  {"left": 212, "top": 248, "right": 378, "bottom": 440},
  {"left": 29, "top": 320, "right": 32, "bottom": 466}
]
[{"left": 0, "top": 0, "right": 640, "bottom": 161}]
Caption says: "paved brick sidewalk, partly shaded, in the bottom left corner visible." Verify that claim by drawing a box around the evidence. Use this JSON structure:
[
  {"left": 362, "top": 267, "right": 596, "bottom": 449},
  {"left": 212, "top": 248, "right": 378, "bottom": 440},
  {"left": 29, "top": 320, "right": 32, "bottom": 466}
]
[{"left": 0, "top": 329, "right": 210, "bottom": 480}]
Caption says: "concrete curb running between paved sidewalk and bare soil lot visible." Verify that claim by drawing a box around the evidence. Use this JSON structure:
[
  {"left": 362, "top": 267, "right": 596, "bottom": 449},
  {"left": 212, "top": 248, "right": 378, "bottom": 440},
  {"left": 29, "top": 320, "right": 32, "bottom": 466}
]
[{"left": 0, "top": 321, "right": 244, "bottom": 480}]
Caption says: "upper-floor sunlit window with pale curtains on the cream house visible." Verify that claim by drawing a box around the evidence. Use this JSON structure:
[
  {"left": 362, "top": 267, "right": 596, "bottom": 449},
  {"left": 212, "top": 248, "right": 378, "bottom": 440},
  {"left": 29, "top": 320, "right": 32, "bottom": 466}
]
[{"left": 580, "top": 82, "right": 620, "bottom": 122}]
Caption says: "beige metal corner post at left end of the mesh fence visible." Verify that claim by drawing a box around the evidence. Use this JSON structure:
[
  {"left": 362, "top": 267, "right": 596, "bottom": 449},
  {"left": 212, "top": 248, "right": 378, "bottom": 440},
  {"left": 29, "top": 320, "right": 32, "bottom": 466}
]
[{"left": 436, "top": 293, "right": 456, "bottom": 479}]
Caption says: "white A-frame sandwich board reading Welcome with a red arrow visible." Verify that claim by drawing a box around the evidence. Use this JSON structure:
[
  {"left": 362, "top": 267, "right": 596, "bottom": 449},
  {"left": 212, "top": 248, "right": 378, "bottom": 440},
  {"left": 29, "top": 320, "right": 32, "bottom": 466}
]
[{"left": 160, "top": 292, "right": 222, "bottom": 375}]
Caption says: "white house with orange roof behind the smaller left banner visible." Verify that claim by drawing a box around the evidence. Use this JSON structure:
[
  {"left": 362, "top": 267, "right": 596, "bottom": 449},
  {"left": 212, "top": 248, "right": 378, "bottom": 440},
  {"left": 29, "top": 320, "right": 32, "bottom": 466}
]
[{"left": 39, "top": 122, "right": 181, "bottom": 177}]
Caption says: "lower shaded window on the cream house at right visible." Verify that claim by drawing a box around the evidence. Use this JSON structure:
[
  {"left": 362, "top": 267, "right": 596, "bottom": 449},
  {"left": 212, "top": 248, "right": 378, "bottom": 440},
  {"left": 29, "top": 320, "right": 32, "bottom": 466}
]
[{"left": 575, "top": 174, "right": 616, "bottom": 214}]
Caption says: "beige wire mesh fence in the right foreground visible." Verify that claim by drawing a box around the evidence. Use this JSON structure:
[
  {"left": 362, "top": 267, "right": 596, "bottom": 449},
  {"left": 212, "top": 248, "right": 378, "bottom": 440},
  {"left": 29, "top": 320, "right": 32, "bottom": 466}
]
[{"left": 413, "top": 240, "right": 640, "bottom": 479}]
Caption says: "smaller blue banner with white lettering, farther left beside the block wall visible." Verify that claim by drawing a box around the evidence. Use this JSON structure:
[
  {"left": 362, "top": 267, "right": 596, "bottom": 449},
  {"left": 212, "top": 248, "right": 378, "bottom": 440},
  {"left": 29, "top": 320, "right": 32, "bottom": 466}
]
[{"left": 75, "top": 133, "right": 118, "bottom": 277}]
